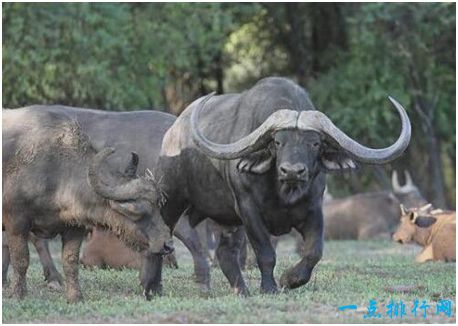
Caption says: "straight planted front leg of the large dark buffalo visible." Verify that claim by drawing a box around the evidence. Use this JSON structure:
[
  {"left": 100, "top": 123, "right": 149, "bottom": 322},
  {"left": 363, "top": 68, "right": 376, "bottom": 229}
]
[{"left": 239, "top": 200, "right": 277, "bottom": 293}]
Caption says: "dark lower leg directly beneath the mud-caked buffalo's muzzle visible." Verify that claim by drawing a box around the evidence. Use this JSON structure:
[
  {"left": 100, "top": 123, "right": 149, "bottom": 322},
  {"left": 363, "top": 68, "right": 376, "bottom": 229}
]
[{"left": 140, "top": 253, "right": 162, "bottom": 300}]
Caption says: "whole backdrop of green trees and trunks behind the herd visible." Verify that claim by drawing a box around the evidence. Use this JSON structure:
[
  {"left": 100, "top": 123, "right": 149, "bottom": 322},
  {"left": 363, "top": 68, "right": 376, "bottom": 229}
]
[{"left": 2, "top": 3, "right": 456, "bottom": 206}]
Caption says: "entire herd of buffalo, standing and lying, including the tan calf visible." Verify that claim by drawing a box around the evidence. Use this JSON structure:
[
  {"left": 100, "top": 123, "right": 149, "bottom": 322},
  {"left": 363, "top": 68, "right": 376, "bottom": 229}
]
[{"left": 2, "top": 77, "right": 456, "bottom": 302}]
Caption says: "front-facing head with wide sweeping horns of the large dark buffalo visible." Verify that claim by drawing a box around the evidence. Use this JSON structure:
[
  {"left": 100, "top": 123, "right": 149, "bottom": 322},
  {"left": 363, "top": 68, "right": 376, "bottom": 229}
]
[{"left": 191, "top": 94, "right": 411, "bottom": 205}]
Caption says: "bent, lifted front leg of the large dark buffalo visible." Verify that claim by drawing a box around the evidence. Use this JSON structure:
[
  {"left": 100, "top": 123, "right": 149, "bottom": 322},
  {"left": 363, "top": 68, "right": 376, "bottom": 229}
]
[{"left": 280, "top": 208, "right": 323, "bottom": 289}]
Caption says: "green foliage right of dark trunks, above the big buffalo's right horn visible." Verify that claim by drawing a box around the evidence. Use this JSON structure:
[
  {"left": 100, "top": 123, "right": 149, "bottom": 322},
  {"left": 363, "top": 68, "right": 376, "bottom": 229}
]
[{"left": 310, "top": 4, "right": 455, "bottom": 144}]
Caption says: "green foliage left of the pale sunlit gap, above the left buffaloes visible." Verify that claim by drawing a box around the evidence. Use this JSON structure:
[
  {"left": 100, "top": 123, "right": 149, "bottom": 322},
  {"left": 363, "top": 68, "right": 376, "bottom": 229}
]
[{"left": 3, "top": 3, "right": 252, "bottom": 110}]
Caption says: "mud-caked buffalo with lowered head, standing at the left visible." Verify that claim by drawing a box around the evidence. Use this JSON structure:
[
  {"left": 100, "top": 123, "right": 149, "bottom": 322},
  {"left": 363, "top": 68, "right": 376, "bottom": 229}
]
[{"left": 2, "top": 107, "right": 171, "bottom": 302}]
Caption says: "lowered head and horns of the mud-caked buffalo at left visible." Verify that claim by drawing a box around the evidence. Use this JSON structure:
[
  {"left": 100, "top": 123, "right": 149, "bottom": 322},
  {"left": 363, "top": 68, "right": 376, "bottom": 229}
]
[{"left": 88, "top": 148, "right": 173, "bottom": 254}]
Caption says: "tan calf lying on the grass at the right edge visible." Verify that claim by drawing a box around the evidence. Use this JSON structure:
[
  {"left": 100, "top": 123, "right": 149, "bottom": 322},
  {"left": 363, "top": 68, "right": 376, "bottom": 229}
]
[{"left": 393, "top": 205, "right": 456, "bottom": 263}]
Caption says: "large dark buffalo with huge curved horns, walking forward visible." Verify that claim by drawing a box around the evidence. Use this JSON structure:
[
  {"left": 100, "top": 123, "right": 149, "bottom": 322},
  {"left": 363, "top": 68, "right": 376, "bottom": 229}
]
[{"left": 158, "top": 78, "right": 411, "bottom": 294}]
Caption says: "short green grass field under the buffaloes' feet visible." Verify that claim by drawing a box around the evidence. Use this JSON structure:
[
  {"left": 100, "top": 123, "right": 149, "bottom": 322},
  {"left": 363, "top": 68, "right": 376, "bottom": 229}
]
[{"left": 2, "top": 239, "right": 456, "bottom": 323}]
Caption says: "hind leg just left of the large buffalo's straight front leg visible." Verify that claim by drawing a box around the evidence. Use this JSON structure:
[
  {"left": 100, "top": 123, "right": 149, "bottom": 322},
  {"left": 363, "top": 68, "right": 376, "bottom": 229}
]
[{"left": 216, "top": 227, "right": 249, "bottom": 295}]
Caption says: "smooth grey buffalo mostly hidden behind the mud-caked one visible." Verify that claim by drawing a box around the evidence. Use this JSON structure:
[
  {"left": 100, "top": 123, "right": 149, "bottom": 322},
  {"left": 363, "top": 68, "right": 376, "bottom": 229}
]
[{"left": 4, "top": 105, "right": 210, "bottom": 292}]
